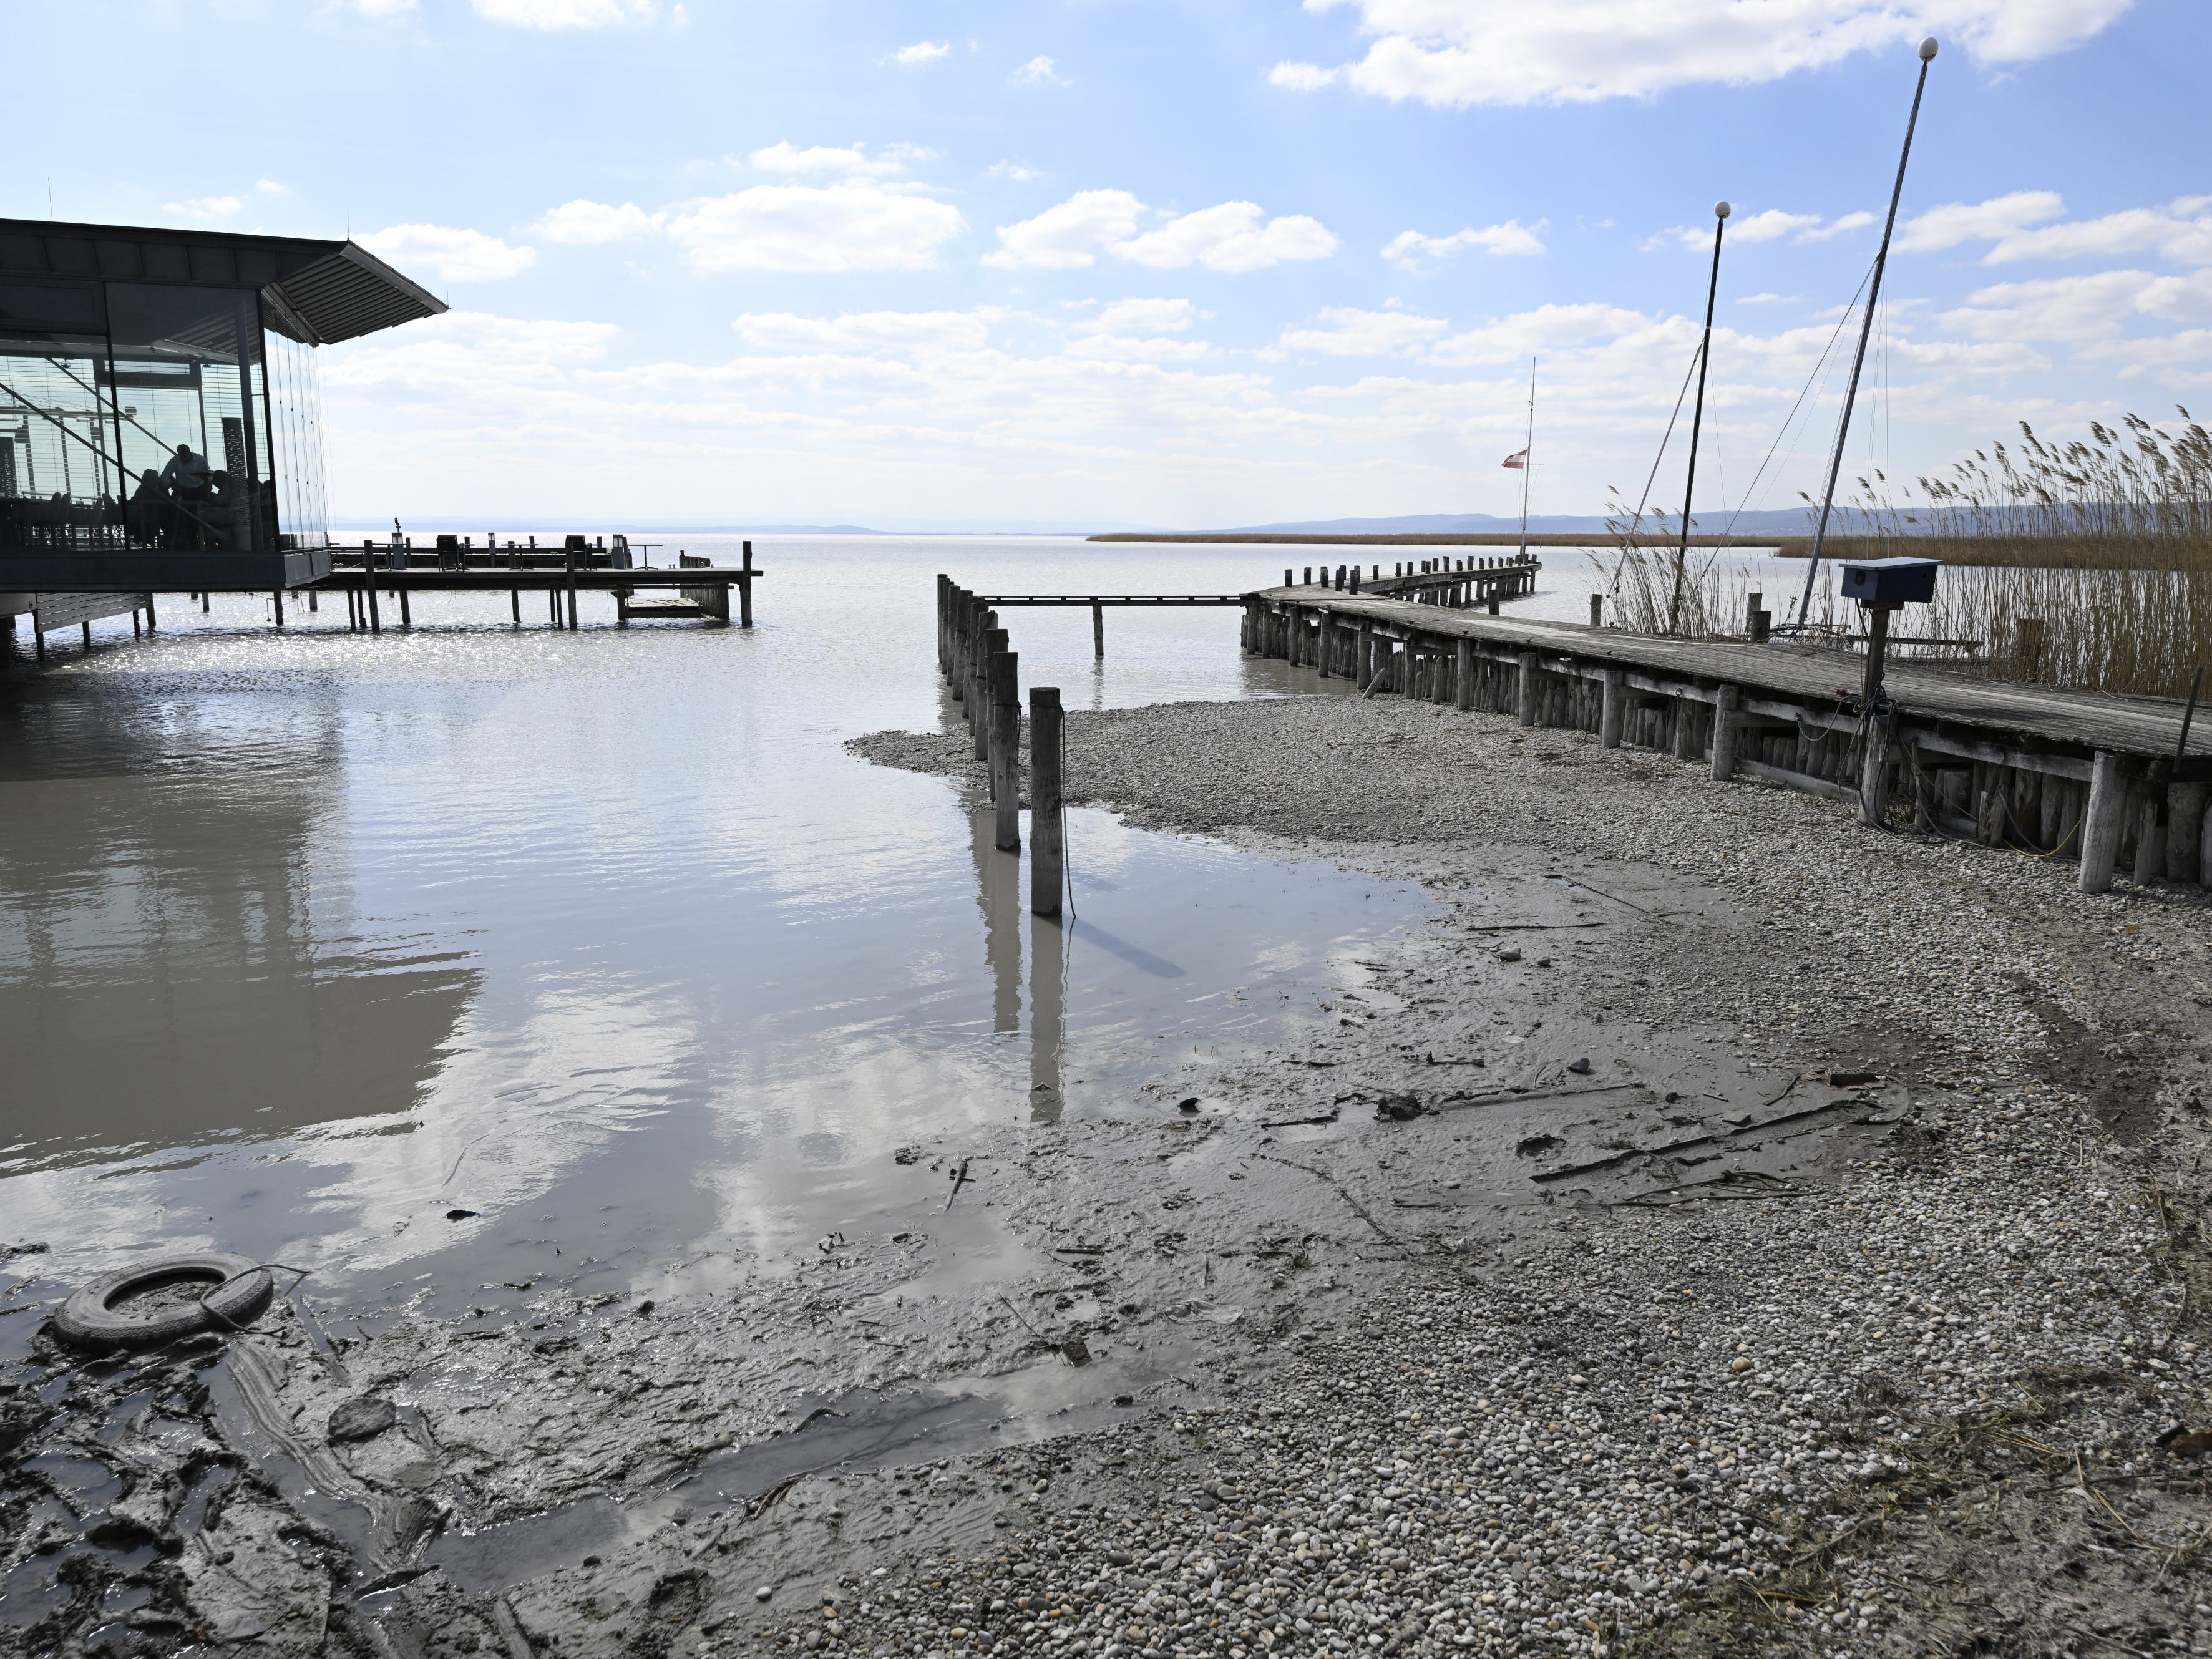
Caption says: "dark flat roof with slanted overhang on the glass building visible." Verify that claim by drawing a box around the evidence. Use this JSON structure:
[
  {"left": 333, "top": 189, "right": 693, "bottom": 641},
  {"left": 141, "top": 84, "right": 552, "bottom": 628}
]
[{"left": 0, "top": 219, "right": 447, "bottom": 345}]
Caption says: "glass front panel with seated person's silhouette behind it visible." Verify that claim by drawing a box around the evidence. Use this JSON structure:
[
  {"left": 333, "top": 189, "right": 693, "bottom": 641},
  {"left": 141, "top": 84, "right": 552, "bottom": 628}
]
[{"left": 106, "top": 283, "right": 276, "bottom": 553}]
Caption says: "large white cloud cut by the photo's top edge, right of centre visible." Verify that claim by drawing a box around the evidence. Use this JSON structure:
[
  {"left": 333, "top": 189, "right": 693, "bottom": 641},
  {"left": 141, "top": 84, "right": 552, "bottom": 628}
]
[{"left": 1270, "top": 0, "right": 2130, "bottom": 109}]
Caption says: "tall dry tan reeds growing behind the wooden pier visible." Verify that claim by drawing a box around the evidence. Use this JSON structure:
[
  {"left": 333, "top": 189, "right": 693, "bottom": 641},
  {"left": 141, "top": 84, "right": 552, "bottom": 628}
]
[{"left": 1606, "top": 409, "right": 2212, "bottom": 697}]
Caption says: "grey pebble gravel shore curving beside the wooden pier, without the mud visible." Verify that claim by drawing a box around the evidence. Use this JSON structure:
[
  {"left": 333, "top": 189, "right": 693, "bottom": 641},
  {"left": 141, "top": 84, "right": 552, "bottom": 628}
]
[{"left": 827, "top": 699, "right": 2212, "bottom": 1659}]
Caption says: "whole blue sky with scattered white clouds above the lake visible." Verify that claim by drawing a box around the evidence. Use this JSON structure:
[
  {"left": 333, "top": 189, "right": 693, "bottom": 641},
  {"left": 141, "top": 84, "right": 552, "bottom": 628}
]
[{"left": 0, "top": 0, "right": 2212, "bottom": 528}]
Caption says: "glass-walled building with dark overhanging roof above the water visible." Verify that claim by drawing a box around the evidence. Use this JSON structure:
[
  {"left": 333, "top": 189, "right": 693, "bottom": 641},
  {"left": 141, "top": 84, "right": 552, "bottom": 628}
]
[{"left": 0, "top": 219, "right": 445, "bottom": 588}]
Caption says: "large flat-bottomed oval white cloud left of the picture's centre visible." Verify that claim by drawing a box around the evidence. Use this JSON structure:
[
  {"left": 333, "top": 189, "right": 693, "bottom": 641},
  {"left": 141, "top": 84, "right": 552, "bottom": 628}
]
[{"left": 666, "top": 179, "right": 967, "bottom": 272}]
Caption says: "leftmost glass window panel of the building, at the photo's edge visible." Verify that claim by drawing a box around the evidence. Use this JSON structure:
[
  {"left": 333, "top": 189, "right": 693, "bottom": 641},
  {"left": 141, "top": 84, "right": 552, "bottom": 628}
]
[{"left": 0, "top": 332, "right": 126, "bottom": 551}]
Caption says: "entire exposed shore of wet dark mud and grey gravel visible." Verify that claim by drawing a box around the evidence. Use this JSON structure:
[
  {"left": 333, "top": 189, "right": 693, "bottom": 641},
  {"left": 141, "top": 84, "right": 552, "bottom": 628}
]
[{"left": 0, "top": 697, "right": 2212, "bottom": 1659}]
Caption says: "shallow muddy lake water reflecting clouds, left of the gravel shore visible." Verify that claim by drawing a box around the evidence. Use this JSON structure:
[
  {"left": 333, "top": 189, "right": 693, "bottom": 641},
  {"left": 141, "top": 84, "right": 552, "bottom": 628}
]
[{"left": 0, "top": 538, "right": 1429, "bottom": 1350}]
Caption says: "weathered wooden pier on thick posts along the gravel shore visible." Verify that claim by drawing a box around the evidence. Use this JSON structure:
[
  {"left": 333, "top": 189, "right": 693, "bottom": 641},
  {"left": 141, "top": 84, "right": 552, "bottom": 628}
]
[{"left": 1243, "top": 584, "right": 2212, "bottom": 892}]
